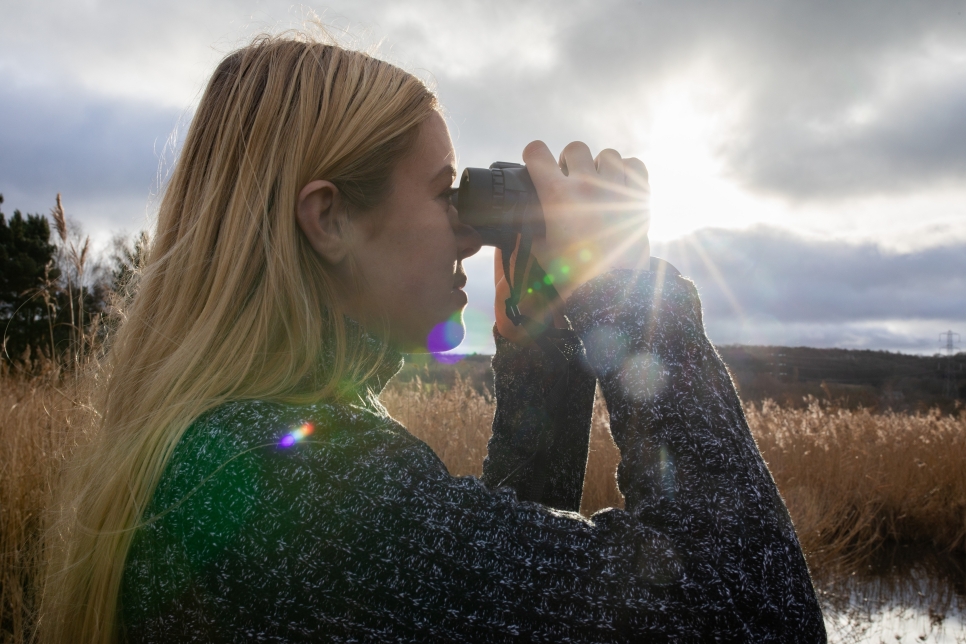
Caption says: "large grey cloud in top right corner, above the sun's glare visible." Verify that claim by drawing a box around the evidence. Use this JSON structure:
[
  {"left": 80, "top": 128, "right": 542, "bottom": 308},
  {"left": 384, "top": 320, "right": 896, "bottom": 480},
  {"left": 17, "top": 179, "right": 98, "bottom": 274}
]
[{"left": 608, "top": 2, "right": 966, "bottom": 200}]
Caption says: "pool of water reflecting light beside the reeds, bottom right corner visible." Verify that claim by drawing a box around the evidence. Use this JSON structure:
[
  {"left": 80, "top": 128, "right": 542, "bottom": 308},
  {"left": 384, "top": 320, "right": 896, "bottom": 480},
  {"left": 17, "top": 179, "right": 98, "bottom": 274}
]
[{"left": 817, "top": 547, "right": 966, "bottom": 644}]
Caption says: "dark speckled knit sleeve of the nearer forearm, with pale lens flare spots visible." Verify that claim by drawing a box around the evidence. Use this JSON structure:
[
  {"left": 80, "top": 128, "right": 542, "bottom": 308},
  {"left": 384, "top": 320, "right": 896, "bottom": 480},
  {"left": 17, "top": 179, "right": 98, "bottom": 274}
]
[{"left": 568, "top": 271, "right": 825, "bottom": 642}]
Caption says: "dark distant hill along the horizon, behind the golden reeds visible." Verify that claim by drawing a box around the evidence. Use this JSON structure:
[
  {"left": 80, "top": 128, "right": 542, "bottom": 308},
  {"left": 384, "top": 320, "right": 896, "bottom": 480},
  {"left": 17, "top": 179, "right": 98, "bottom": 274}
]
[{"left": 397, "top": 345, "right": 966, "bottom": 413}]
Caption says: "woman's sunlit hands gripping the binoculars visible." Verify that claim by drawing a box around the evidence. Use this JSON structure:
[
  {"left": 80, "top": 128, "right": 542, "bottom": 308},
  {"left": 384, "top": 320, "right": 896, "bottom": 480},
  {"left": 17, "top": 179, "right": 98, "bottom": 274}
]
[{"left": 494, "top": 141, "right": 650, "bottom": 344}]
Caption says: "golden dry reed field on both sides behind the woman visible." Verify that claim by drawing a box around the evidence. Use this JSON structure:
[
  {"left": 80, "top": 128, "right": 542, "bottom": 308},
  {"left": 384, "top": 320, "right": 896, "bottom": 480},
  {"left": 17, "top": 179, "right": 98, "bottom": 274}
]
[{"left": 0, "top": 367, "right": 966, "bottom": 642}]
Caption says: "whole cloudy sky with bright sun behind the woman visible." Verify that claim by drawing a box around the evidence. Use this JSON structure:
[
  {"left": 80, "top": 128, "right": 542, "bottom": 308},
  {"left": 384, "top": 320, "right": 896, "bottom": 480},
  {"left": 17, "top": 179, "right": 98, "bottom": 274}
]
[{"left": 0, "top": 0, "right": 966, "bottom": 354}]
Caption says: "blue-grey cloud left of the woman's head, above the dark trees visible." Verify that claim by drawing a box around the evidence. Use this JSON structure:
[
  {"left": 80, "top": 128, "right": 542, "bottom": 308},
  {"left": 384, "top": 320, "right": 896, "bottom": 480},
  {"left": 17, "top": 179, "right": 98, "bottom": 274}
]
[{"left": 0, "top": 77, "right": 180, "bottom": 214}]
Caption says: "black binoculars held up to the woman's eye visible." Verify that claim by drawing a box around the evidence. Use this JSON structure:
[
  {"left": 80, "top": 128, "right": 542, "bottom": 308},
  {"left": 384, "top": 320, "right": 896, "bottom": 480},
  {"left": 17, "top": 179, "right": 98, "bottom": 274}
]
[{"left": 451, "top": 161, "right": 546, "bottom": 251}]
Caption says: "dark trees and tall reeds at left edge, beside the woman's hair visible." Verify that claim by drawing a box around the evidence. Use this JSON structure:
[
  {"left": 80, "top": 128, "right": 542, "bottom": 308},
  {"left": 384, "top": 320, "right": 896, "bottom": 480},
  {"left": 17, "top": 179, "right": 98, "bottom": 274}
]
[{"left": 0, "top": 194, "right": 148, "bottom": 365}]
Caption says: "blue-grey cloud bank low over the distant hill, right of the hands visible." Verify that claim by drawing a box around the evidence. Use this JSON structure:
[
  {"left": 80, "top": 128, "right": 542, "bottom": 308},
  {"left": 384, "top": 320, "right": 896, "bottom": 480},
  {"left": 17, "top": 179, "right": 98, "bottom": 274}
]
[{"left": 652, "top": 227, "right": 966, "bottom": 350}]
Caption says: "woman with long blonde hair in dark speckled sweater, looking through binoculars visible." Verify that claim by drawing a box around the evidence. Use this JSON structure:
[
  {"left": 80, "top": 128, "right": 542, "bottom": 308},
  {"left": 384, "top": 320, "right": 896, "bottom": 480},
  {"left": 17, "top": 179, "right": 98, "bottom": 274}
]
[{"left": 40, "top": 32, "right": 825, "bottom": 642}]
